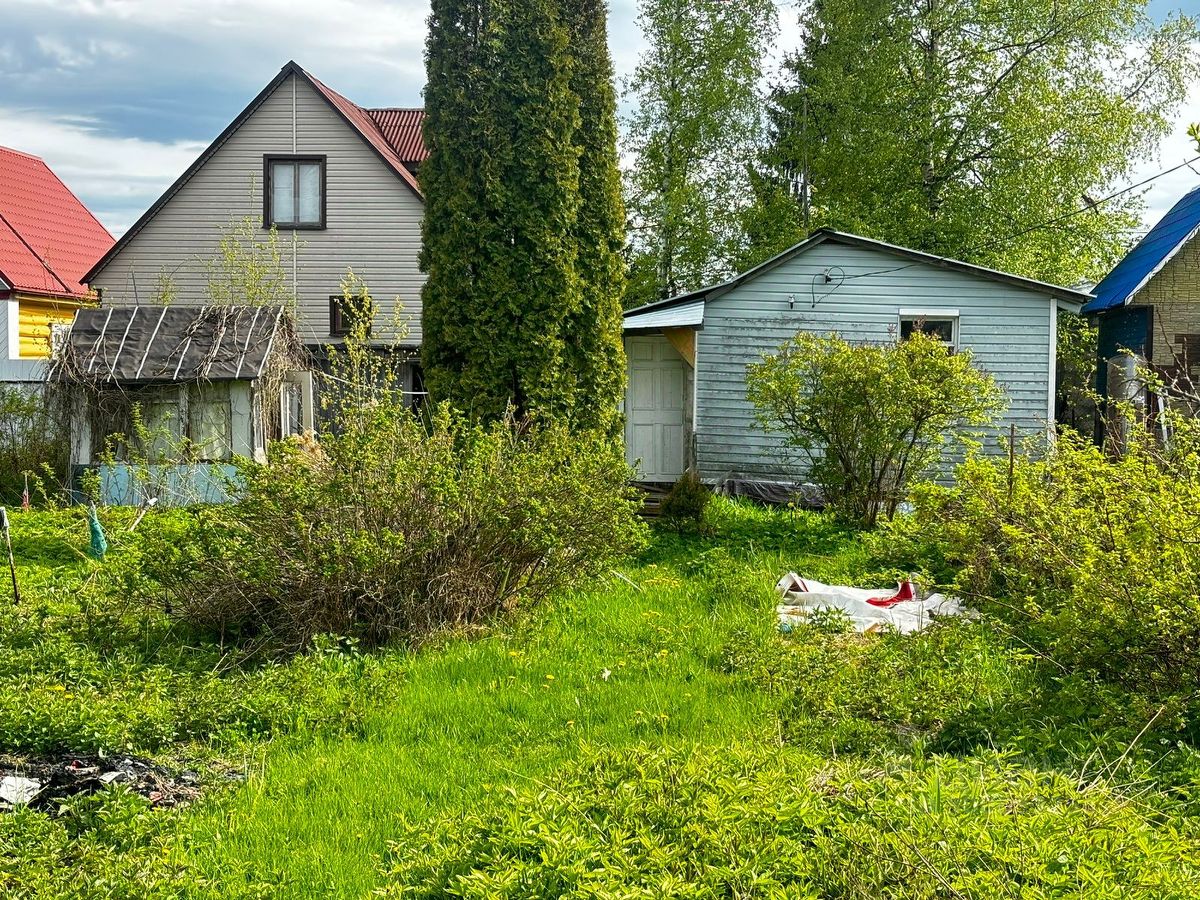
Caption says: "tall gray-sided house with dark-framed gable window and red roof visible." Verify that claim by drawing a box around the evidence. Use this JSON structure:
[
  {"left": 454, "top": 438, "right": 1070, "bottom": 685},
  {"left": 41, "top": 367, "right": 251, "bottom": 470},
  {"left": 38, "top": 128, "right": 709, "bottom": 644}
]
[{"left": 85, "top": 62, "right": 426, "bottom": 380}]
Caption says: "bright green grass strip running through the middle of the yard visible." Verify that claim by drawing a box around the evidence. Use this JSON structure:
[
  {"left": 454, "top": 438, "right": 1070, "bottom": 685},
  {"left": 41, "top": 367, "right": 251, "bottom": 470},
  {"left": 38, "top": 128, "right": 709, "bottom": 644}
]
[{"left": 187, "top": 505, "right": 853, "bottom": 896}]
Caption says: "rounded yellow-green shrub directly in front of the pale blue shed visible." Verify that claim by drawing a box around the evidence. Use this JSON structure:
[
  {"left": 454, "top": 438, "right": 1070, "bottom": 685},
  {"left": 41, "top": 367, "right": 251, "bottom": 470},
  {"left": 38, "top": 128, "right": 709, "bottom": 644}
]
[{"left": 746, "top": 331, "right": 1001, "bottom": 526}]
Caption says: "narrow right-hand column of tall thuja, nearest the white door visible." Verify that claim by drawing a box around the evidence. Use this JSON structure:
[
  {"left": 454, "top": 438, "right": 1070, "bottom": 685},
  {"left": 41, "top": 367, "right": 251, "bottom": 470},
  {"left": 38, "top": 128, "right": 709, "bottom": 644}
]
[{"left": 560, "top": 0, "right": 625, "bottom": 431}]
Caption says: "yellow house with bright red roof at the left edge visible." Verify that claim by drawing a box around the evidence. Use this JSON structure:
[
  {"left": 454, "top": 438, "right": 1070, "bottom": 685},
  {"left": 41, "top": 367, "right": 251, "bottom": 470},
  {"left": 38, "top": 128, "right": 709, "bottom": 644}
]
[{"left": 0, "top": 146, "right": 113, "bottom": 384}]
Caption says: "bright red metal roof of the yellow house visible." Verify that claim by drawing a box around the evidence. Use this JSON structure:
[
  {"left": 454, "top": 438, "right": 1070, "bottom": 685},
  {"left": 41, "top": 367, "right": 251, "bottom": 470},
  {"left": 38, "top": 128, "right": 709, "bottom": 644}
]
[{"left": 0, "top": 146, "right": 113, "bottom": 298}]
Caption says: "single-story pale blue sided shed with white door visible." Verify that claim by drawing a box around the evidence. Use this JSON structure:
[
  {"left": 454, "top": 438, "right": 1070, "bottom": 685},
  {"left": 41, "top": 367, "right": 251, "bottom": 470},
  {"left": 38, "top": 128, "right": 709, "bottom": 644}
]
[{"left": 624, "top": 230, "right": 1091, "bottom": 482}]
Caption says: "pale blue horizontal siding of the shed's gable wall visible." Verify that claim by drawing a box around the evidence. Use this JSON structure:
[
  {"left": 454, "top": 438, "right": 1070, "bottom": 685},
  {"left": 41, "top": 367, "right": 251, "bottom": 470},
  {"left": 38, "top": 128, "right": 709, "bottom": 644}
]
[{"left": 695, "top": 241, "right": 1055, "bottom": 479}]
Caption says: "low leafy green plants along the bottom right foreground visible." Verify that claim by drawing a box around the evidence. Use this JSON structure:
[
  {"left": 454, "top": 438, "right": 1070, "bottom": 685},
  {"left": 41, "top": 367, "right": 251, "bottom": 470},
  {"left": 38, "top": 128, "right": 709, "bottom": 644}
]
[{"left": 384, "top": 746, "right": 1200, "bottom": 900}]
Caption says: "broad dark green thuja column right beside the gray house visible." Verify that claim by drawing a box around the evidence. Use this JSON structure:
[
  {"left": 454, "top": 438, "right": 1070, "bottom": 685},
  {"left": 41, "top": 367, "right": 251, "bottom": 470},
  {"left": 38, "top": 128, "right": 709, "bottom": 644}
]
[{"left": 421, "top": 0, "right": 585, "bottom": 420}]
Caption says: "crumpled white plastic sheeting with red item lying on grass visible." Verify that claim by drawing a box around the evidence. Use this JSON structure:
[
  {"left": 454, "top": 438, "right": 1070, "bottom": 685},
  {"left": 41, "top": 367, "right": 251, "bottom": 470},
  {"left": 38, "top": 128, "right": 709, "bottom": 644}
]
[{"left": 775, "top": 572, "right": 968, "bottom": 635}]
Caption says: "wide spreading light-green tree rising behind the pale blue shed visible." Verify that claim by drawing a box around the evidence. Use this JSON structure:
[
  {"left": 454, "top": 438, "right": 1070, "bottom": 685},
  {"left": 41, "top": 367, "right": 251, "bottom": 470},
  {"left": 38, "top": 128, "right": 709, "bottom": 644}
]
[{"left": 751, "top": 0, "right": 1195, "bottom": 283}]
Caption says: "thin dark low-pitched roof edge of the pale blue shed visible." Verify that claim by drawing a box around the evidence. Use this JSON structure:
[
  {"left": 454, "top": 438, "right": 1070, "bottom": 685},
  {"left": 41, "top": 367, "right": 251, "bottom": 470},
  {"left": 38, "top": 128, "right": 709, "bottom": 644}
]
[{"left": 625, "top": 228, "right": 1092, "bottom": 319}]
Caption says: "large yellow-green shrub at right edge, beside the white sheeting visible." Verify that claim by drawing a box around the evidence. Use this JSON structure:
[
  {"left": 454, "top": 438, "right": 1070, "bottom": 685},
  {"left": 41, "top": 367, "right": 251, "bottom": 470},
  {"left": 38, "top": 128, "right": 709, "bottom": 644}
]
[{"left": 880, "top": 419, "right": 1200, "bottom": 698}]
